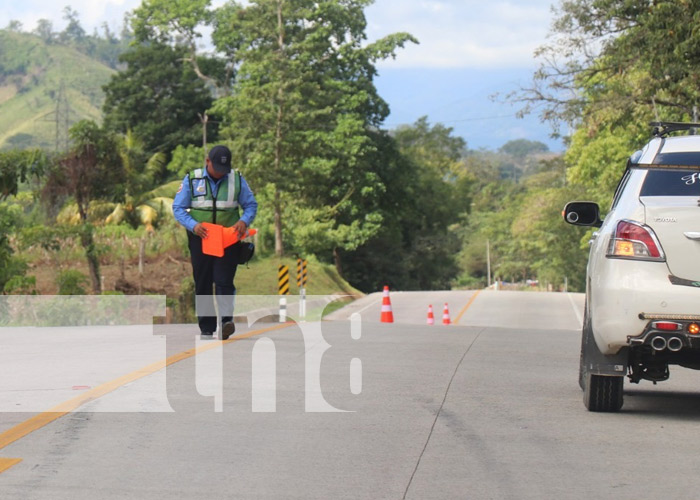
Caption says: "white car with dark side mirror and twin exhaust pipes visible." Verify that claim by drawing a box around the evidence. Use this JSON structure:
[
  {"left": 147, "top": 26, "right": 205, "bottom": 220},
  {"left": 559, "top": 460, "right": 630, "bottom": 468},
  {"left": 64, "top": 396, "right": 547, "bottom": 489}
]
[{"left": 564, "top": 123, "right": 700, "bottom": 411}]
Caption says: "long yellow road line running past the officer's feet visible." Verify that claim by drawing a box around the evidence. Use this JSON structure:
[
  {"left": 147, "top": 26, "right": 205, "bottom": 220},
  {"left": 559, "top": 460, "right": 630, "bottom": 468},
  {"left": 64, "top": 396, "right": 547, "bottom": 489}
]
[{"left": 0, "top": 323, "right": 294, "bottom": 473}]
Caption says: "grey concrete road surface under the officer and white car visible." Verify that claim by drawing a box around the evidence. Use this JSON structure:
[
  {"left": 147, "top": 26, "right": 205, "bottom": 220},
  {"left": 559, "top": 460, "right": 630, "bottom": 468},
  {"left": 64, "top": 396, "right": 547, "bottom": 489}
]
[{"left": 0, "top": 291, "right": 700, "bottom": 500}]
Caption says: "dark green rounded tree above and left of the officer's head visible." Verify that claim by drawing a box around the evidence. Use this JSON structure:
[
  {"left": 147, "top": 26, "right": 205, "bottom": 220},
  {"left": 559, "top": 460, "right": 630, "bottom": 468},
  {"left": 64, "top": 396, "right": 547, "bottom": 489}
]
[{"left": 103, "top": 43, "right": 215, "bottom": 154}]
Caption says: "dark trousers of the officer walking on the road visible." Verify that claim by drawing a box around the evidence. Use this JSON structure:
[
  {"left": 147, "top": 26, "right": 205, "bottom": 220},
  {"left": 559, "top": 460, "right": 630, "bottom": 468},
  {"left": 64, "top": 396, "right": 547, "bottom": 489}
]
[{"left": 187, "top": 231, "right": 241, "bottom": 333}]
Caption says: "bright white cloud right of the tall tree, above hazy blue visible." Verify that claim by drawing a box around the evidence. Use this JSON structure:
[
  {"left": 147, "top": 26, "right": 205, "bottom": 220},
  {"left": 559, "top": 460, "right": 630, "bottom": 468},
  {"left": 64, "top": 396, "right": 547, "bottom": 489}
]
[{"left": 366, "top": 0, "right": 553, "bottom": 68}]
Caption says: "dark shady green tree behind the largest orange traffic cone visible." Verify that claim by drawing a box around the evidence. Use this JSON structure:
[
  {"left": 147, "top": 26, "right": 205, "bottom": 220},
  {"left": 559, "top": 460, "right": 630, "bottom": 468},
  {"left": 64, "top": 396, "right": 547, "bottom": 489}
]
[{"left": 344, "top": 117, "right": 473, "bottom": 291}]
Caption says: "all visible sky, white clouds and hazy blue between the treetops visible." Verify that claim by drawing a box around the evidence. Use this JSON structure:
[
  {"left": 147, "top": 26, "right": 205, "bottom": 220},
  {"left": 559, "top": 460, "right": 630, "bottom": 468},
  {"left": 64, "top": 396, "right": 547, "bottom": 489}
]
[{"left": 0, "top": 0, "right": 564, "bottom": 151}]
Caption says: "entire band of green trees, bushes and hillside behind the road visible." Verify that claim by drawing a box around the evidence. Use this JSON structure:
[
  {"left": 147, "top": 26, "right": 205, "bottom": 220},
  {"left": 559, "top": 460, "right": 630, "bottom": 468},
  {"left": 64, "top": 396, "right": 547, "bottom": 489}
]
[{"left": 0, "top": 0, "right": 688, "bottom": 306}]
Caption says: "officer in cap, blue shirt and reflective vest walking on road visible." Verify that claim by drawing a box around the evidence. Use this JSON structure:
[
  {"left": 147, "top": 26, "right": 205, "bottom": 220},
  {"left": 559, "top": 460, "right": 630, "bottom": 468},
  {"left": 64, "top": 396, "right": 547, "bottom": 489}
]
[{"left": 173, "top": 146, "right": 258, "bottom": 340}]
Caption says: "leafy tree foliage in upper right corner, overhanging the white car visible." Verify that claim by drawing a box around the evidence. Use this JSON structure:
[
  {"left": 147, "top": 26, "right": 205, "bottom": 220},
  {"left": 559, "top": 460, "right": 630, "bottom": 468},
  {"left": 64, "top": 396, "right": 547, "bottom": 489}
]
[{"left": 517, "top": 0, "right": 700, "bottom": 202}]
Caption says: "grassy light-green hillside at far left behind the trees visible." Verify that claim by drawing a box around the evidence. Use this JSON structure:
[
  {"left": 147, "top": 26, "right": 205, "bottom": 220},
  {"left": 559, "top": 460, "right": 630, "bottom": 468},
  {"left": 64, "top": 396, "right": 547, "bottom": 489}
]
[{"left": 0, "top": 30, "right": 114, "bottom": 150}]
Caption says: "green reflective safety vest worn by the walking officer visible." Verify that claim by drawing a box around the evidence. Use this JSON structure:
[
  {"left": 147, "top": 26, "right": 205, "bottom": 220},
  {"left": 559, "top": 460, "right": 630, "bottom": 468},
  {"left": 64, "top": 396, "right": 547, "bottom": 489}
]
[{"left": 189, "top": 168, "right": 241, "bottom": 227}]
